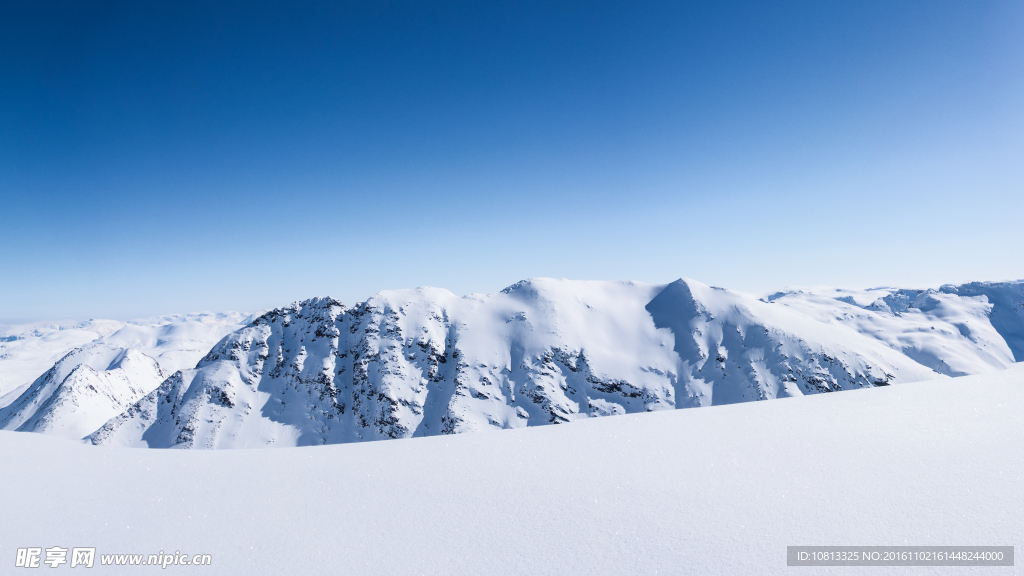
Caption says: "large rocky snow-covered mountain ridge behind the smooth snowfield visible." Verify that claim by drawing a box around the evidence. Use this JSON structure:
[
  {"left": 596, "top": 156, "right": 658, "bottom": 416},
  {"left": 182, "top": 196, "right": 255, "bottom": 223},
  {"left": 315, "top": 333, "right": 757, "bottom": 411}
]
[{"left": 83, "top": 279, "right": 1021, "bottom": 448}]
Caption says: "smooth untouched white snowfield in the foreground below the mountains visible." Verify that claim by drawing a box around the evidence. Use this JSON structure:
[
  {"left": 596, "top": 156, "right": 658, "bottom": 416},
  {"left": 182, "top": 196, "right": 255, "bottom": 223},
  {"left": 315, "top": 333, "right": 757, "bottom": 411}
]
[{"left": 0, "top": 366, "right": 1024, "bottom": 576}]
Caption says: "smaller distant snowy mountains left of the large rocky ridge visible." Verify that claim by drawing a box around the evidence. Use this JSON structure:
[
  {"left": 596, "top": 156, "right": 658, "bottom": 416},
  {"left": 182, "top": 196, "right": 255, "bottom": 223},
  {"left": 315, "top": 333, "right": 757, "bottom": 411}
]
[{"left": 0, "top": 313, "right": 244, "bottom": 438}]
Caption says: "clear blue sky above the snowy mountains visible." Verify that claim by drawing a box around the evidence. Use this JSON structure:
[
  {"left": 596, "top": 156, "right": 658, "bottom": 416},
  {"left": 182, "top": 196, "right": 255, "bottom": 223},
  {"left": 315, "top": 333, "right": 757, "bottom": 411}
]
[{"left": 0, "top": 0, "right": 1024, "bottom": 323}]
